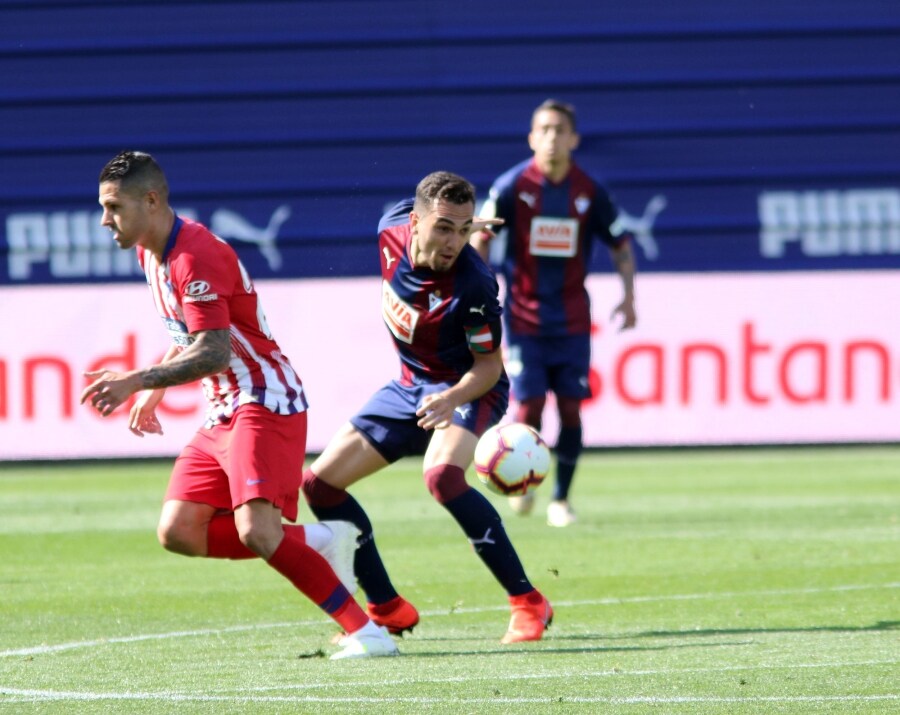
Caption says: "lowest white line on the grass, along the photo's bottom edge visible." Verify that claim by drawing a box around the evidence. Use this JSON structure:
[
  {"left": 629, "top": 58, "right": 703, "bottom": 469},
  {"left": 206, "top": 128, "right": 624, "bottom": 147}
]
[{"left": 0, "top": 686, "right": 900, "bottom": 705}]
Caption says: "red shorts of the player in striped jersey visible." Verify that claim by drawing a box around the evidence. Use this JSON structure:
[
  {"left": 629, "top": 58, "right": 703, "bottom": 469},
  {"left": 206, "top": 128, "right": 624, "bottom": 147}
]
[{"left": 166, "top": 404, "right": 306, "bottom": 521}]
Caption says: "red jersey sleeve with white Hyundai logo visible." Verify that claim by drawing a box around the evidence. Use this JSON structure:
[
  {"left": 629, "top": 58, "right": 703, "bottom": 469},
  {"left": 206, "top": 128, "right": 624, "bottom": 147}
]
[{"left": 172, "top": 238, "right": 234, "bottom": 335}]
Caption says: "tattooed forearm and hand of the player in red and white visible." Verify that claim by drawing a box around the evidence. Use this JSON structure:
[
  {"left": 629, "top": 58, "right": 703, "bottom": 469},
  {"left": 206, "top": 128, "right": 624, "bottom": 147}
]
[{"left": 80, "top": 330, "right": 231, "bottom": 417}]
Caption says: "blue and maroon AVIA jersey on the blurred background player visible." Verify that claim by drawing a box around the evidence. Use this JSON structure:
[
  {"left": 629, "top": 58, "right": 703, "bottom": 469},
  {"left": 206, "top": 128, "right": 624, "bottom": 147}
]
[{"left": 481, "top": 159, "right": 628, "bottom": 337}]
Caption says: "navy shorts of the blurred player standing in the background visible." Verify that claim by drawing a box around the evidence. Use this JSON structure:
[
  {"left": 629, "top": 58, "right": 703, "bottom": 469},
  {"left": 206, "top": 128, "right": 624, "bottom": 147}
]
[{"left": 506, "top": 332, "right": 591, "bottom": 402}]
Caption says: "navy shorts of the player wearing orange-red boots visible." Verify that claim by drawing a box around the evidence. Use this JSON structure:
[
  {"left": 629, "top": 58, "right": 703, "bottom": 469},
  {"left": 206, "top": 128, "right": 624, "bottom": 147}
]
[{"left": 350, "top": 376, "right": 509, "bottom": 462}]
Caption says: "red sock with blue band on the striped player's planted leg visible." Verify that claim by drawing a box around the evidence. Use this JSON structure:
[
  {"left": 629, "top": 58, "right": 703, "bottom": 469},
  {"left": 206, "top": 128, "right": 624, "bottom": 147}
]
[{"left": 269, "top": 529, "right": 369, "bottom": 633}]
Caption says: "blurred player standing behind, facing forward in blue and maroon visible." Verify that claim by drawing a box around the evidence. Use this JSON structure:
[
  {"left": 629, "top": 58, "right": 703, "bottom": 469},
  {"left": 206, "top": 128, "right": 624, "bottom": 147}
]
[{"left": 472, "top": 99, "right": 637, "bottom": 526}]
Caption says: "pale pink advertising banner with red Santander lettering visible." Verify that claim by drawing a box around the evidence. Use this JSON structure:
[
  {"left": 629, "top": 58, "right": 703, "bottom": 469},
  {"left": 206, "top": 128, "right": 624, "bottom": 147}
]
[{"left": 0, "top": 271, "right": 900, "bottom": 460}]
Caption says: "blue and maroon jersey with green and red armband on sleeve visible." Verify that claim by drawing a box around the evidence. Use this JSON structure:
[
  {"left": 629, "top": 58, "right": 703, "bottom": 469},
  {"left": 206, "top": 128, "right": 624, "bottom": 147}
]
[{"left": 378, "top": 199, "right": 506, "bottom": 385}]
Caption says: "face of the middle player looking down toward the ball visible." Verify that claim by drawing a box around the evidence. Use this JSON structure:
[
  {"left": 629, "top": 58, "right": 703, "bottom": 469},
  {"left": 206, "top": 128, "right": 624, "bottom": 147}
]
[{"left": 410, "top": 200, "right": 475, "bottom": 272}]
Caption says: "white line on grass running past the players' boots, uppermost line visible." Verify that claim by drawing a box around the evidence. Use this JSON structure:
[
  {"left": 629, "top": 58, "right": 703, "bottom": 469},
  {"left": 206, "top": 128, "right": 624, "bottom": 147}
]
[{"left": 0, "top": 583, "right": 900, "bottom": 658}]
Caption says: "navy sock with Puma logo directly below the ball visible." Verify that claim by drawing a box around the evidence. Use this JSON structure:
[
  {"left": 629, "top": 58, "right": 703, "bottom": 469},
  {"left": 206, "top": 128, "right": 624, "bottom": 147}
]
[{"left": 443, "top": 487, "right": 534, "bottom": 596}]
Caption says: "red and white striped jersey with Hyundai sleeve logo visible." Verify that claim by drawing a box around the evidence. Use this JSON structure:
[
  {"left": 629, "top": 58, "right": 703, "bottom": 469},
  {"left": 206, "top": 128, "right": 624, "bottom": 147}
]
[{"left": 137, "top": 216, "right": 308, "bottom": 427}]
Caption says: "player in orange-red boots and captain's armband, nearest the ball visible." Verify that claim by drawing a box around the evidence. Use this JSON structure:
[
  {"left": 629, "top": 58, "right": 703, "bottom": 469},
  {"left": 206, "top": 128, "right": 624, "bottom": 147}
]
[{"left": 303, "top": 172, "right": 553, "bottom": 643}]
